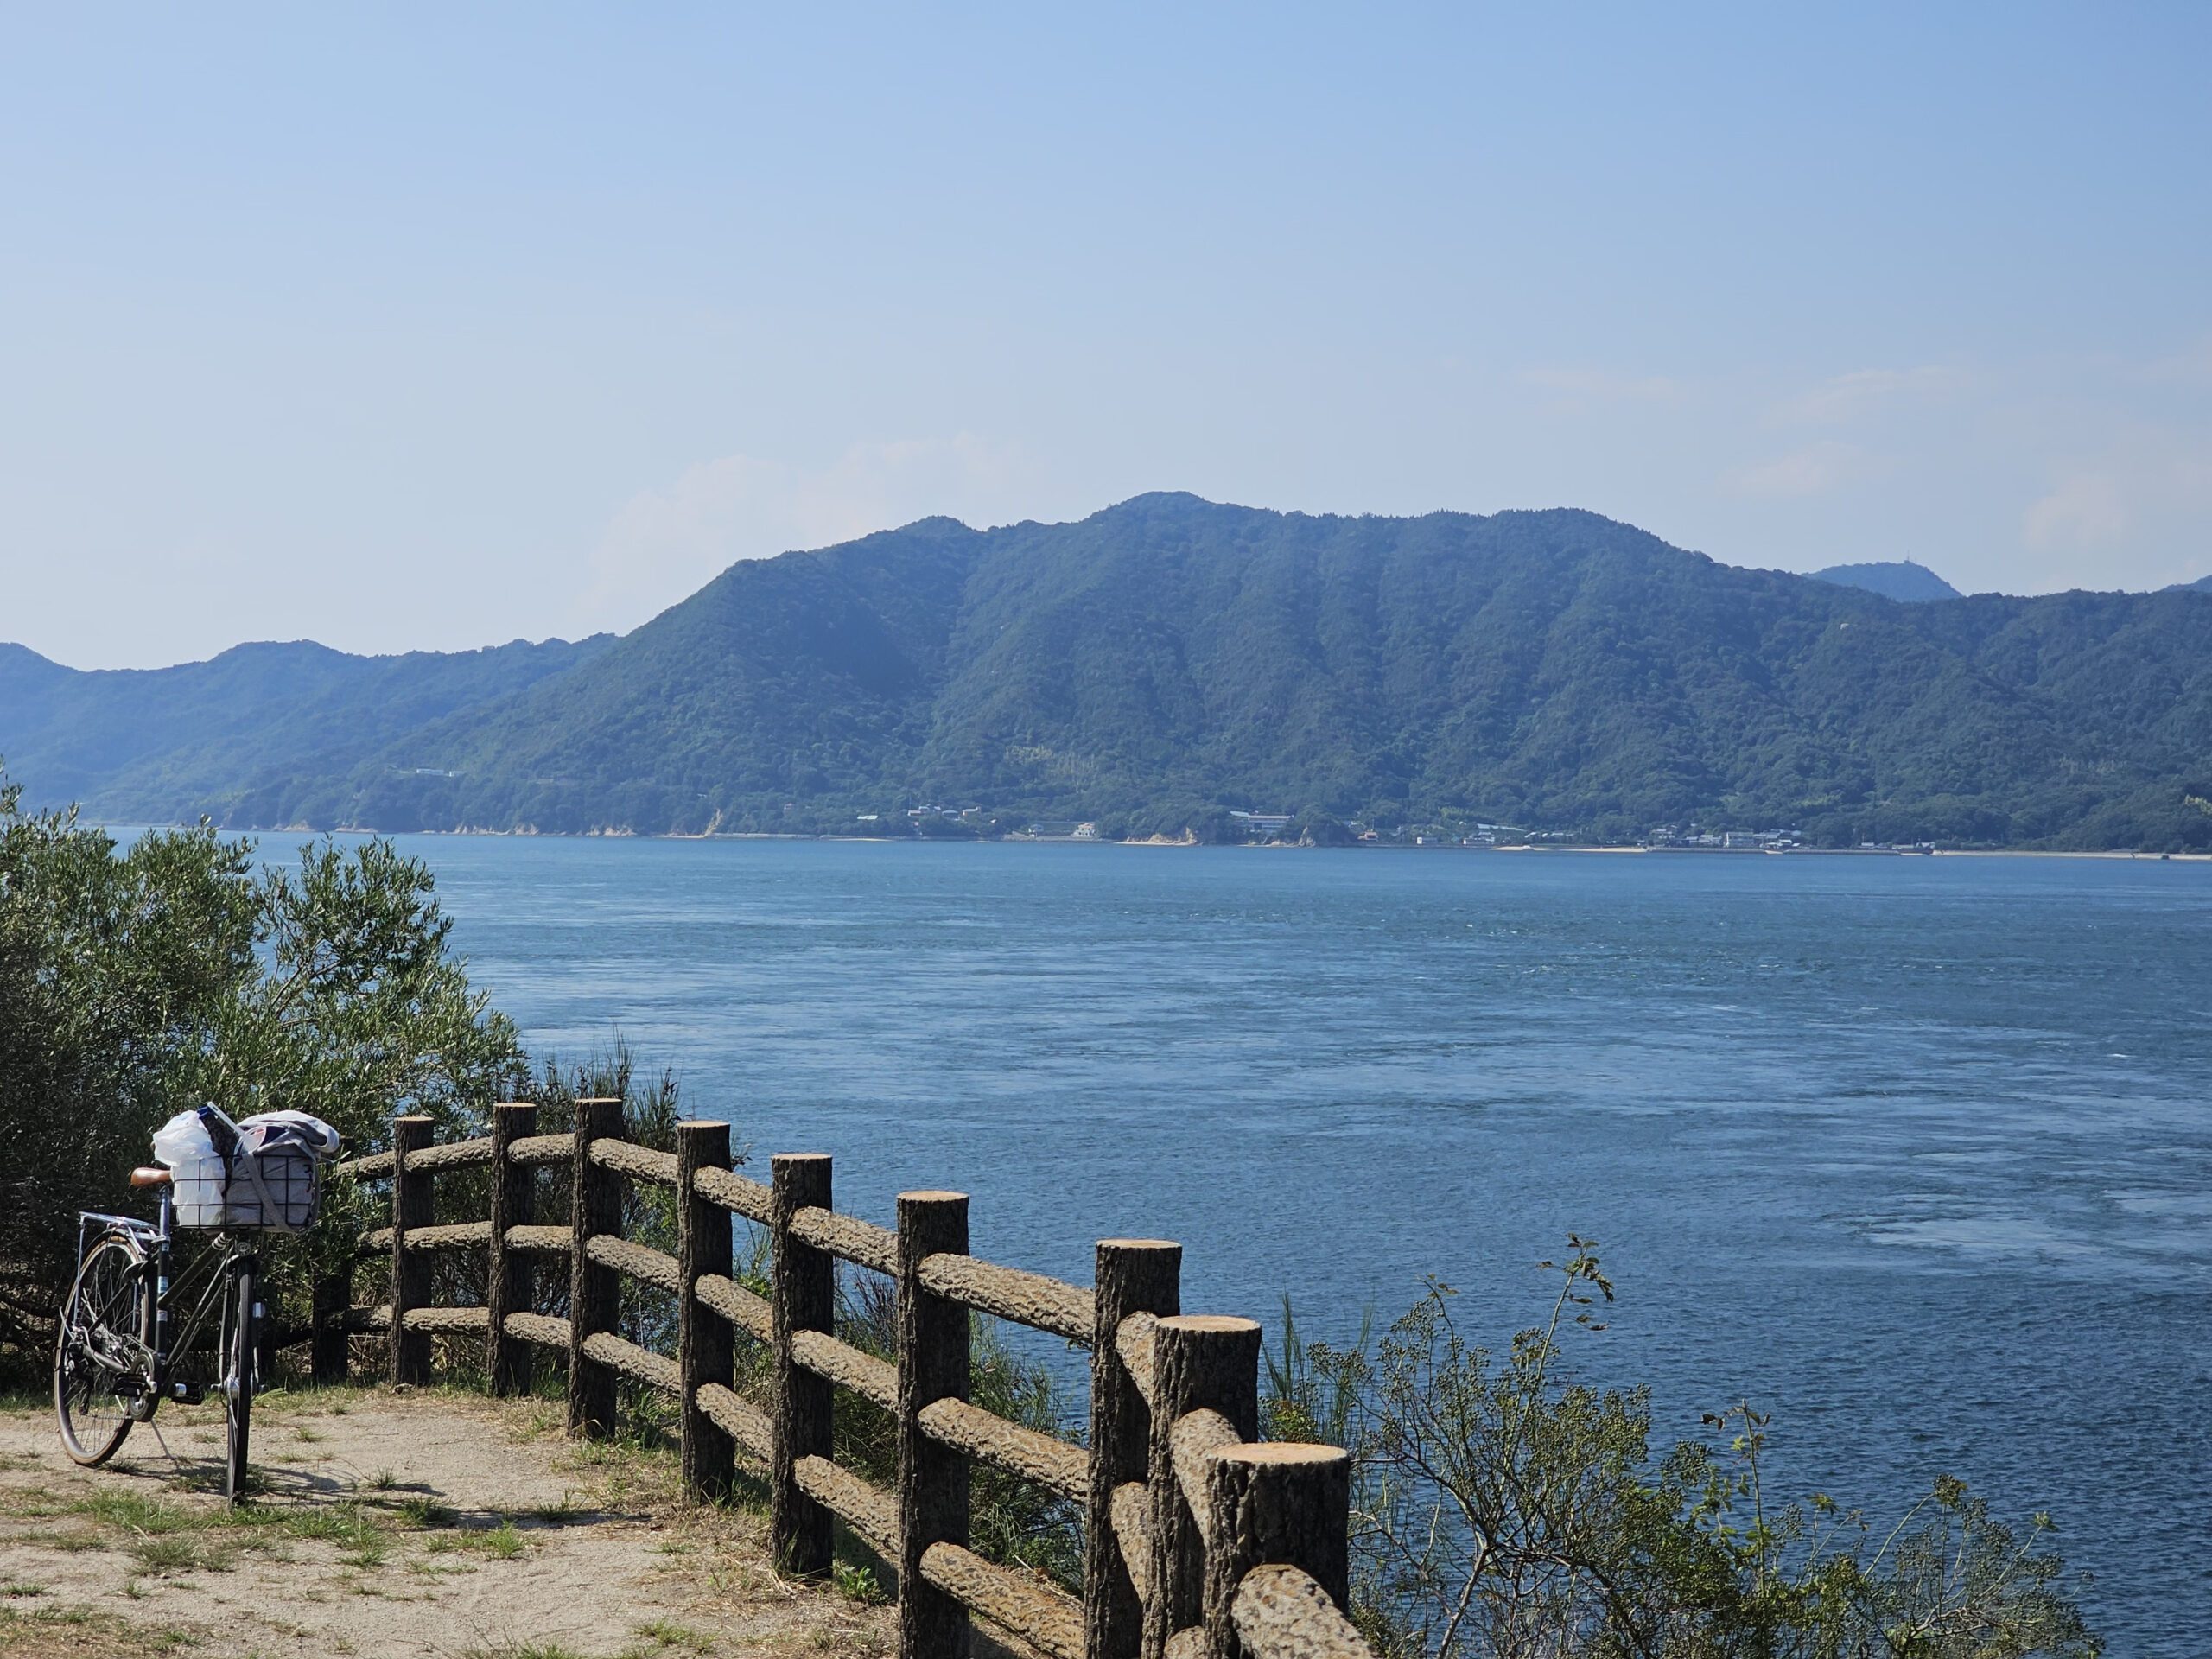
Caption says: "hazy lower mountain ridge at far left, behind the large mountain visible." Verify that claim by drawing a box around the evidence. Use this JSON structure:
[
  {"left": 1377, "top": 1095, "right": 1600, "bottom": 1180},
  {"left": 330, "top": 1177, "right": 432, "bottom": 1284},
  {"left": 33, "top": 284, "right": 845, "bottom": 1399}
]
[{"left": 0, "top": 635, "right": 613, "bottom": 823}]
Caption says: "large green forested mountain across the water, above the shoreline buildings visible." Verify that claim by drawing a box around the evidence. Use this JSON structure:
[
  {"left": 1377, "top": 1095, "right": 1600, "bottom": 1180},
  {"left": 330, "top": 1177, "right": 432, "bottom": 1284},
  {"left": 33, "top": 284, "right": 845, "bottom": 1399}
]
[{"left": 0, "top": 495, "right": 2212, "bottom": 847}]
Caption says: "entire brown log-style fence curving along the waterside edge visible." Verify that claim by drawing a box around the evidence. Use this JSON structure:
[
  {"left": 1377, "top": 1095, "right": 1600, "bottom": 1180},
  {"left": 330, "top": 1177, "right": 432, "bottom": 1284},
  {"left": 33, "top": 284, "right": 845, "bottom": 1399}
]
[{"left": 299, "top": 1099, "right": 1371, "bottom": 1659}]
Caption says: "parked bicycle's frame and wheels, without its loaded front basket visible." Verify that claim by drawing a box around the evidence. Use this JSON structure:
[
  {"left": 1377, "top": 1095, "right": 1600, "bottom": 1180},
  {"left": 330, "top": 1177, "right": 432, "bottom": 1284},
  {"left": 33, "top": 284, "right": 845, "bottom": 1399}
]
[{"left": 53, "top": 1113, "right": 321, "bottom": 1504}]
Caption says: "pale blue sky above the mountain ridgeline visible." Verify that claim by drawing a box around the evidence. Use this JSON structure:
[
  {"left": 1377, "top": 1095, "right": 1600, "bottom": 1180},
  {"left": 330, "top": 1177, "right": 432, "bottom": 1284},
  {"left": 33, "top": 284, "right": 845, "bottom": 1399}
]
[{"left": 0, "top": 4, "right": 2212, "bottom": 666}]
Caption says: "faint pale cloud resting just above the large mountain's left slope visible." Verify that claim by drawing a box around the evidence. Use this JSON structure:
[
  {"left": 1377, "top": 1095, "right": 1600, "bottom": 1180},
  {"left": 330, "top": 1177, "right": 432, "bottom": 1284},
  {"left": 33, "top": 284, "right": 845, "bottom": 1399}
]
[{"left": 580, "top": 434, "right": 1020, "bottom": 626}]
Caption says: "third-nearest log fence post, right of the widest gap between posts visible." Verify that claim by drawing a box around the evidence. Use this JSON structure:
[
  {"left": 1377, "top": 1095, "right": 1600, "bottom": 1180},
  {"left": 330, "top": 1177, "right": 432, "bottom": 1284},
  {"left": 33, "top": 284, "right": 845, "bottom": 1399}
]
[{"left": 1084, "top": 1239, "right": 1184, "bottom": 1659}]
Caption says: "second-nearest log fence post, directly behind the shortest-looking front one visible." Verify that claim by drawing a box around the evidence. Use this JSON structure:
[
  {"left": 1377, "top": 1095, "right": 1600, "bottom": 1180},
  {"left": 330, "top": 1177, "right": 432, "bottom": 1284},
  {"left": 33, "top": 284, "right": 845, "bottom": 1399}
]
[{"left": 1144, "top": 1314, "right": 1259, "bottom": 1659}]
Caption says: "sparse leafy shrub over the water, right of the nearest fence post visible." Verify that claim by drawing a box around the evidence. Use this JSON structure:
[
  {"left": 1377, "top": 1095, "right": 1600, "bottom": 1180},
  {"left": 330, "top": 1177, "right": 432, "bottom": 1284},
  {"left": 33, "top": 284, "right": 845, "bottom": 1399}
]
[{"left": 1263, "top": 1239, "right": 2097, "bottom": 1659}]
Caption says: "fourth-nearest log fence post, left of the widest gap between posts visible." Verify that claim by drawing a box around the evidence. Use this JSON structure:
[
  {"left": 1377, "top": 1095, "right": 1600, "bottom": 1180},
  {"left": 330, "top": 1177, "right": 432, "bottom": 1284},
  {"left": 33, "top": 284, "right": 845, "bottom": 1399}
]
[{"left": 898, "top": 1192, "right": 969, "bottom": 1659}]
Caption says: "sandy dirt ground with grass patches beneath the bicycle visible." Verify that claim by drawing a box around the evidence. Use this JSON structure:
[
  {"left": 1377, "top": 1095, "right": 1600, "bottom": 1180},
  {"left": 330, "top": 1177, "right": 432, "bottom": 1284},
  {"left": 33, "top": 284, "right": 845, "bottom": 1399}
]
[{"left": 0, "top": 1389, "right": 892, "bottom": 1659}]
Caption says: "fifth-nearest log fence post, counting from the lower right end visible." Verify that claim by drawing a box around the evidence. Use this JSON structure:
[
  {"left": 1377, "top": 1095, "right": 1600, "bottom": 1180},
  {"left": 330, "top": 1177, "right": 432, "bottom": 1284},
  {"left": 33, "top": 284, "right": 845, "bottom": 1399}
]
[{"left": 767, "top": 1153, "right": 836, "bottom": 1575}]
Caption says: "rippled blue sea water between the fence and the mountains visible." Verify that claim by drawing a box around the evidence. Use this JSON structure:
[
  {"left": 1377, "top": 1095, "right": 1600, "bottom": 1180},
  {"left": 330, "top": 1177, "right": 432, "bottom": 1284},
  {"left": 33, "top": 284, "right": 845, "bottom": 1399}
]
[{"left": 389, "top": 838, "right": 2212, "bottom": 1659}]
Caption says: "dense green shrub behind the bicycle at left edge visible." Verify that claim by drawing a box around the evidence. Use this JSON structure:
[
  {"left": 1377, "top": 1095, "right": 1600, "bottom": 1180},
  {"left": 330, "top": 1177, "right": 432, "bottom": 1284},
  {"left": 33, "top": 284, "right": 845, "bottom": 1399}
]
[{"left": 0, "top": 779, "right": 522, "bottom": 1380}]
